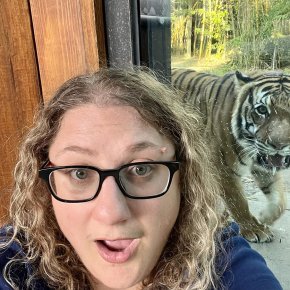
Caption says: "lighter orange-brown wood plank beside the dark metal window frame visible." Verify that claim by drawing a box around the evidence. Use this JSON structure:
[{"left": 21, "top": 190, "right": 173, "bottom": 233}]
[{"left": 30, "top": 0, "right": 105, "bottom": 100}]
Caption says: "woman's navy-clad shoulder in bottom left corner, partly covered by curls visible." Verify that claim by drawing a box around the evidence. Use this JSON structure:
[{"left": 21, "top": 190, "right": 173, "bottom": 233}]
[{"left": 0, "top": 226, "right": 49, "bottom": 290}]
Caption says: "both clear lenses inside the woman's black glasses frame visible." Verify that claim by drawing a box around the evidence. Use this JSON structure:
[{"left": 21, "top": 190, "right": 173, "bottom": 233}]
[{"left": 49, "top": 164, "right": 170, "bottom": 200}]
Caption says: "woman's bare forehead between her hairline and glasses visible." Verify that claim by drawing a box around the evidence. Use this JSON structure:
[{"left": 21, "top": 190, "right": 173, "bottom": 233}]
[{"left": 49, "top": 104, "right": 173, "bottom": 160}]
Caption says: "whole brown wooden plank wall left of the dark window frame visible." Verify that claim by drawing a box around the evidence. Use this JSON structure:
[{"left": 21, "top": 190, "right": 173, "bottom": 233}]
[{"left": 0, "top": 0, "right": 106, "bottom": 224}]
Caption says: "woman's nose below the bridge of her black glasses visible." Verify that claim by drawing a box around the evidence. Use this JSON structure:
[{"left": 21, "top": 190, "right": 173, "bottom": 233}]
[{"left": 93, "top": 176, "right": 131, "bottom": 225}]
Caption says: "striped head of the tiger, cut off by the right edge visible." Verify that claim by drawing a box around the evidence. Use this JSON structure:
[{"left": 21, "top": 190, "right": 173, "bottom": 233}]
[{"left": 231, "top": 72, "right": 290, "bottom": 170}]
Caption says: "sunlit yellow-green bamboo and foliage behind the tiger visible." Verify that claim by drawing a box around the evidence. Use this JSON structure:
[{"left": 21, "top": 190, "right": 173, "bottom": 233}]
[{"left": 172, "top": 0, "right": 290, "bottom": 69}]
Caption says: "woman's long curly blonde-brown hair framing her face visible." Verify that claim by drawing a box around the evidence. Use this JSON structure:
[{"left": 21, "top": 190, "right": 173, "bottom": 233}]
[{"left": 1, "top": 68, "right": 222, "bottom": 290}]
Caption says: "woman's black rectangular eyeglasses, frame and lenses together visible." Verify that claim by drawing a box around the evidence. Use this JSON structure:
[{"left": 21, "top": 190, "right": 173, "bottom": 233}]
[{"left": 39, "top": 161, "right": 180, "bottom": 203}]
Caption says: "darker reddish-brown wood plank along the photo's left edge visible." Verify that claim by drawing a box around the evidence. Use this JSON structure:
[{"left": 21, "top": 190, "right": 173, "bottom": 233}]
[{"left": 0, "top": 0, "right": 41, "bottom": 224}]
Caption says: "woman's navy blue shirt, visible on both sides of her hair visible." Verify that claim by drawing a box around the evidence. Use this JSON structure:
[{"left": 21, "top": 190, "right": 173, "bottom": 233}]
[{"left": 0, "top": 223, "right": 282, "bottom": 290}]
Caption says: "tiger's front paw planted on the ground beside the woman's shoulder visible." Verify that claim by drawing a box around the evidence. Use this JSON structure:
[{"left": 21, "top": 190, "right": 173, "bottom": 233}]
[{"left": 241, "top": 224, "right": 274, "bottom": 243}]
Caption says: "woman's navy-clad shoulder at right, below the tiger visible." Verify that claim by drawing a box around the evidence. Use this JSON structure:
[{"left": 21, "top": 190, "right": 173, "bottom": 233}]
[{"left": 218, "top": 223, "right": 282, "bottom": 290}]
